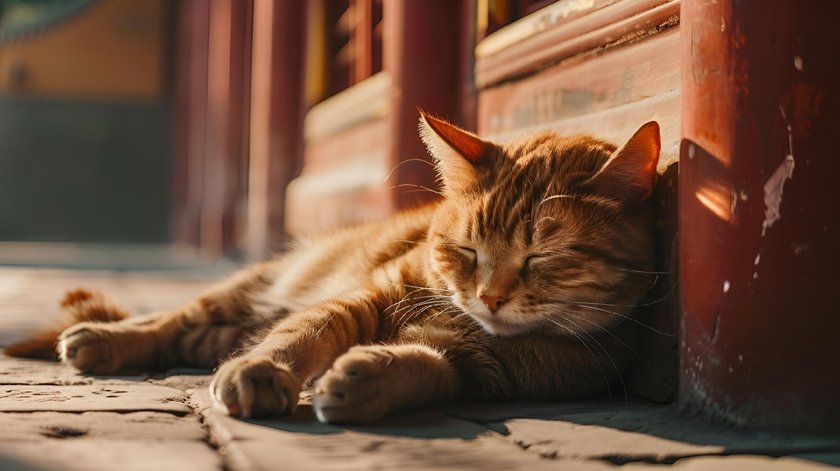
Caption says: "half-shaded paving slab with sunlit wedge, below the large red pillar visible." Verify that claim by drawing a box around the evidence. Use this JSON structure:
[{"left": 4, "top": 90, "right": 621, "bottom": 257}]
[{"left": 447, "top": 400, "right": 840, "bottom": 464}]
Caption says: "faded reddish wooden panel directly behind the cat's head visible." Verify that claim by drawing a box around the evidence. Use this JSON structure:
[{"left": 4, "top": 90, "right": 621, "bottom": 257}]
[{"left": 478, "top": 31, "right": 680, "bottom": 171}]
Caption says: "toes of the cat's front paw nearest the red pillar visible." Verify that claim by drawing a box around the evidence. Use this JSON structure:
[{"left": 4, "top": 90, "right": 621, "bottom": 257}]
[{"left": 312, "top": 347, "right": 394, "bottom": 423}]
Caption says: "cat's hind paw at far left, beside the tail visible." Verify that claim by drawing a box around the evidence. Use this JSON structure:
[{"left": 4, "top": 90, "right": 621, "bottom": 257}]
[{"left": 57, "top": 322, "right": 121, "bottom": 374}]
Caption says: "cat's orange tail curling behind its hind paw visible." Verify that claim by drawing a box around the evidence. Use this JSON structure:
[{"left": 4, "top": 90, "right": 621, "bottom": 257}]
[{"left": 3, "top": 289, "right": 128, "bottom": 360}]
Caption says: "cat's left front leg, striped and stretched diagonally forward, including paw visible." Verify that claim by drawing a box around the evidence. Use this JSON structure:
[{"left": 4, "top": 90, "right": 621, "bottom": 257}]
[{"left": 210, "top": 285, "right": 404, "bottom": 417}]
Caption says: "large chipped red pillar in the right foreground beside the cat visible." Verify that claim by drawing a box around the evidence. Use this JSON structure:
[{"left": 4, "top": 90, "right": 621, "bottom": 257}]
[{"left": 679, "top": 0, "right": 840, "bottom": 429}]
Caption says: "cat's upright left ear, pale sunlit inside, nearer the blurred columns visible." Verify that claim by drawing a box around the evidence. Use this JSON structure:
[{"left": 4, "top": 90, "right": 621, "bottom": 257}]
[{"left": 420, "top": 111, "right": 491, "bottom": 193}]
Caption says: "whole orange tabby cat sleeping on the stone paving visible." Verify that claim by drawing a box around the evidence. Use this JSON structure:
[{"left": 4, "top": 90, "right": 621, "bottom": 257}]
[{"left": 7, "top": 114, "right": 660, "bottom": 422}]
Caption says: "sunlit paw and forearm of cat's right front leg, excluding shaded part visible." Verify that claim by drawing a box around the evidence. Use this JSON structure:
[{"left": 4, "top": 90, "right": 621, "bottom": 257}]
[{"left": 313, "top": 344, "right": 459, "bottom": 423}]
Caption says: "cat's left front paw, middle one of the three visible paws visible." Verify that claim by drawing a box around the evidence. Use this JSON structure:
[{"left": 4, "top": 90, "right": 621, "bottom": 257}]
[{"left": 210, "top": 356, "right": 301, "bottom": 417}]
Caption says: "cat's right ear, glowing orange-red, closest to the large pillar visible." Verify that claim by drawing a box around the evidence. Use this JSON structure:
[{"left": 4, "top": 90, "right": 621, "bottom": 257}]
[{"left": 583, "top": 121, "right": 662, "bottom": 207}]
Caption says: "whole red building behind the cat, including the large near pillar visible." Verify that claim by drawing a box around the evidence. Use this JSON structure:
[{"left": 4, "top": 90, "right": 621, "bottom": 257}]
[{"left": 0, "top": 0, "right": 840, "bottom": 427}]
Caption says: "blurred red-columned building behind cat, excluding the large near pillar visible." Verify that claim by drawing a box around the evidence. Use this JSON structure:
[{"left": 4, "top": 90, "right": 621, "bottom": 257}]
[{"left": 0, "top": 0, "right": 679, "bottom": 266}]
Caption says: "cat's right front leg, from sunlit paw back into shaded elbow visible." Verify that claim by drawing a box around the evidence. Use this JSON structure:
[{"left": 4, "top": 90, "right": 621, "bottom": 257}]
[{"left": 313, "top": 326, "right": 627, "bottom": 423}]
